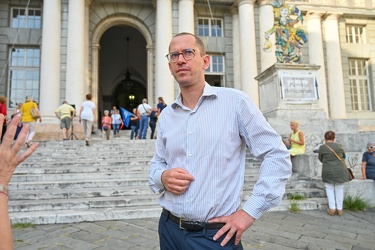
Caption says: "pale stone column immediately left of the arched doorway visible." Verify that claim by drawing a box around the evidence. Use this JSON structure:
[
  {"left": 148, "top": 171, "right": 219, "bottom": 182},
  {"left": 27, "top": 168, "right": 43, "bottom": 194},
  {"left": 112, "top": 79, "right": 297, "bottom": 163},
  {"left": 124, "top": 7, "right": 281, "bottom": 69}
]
[{"left": 65, "top": 0, "right": 86, "bottom": 111}]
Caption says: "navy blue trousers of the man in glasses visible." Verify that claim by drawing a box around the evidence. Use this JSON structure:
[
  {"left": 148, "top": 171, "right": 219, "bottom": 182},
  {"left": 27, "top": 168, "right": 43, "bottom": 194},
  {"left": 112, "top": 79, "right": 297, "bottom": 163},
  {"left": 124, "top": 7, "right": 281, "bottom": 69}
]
[{"left": 159, "top": 214, "right": 243, "bottom": 250}]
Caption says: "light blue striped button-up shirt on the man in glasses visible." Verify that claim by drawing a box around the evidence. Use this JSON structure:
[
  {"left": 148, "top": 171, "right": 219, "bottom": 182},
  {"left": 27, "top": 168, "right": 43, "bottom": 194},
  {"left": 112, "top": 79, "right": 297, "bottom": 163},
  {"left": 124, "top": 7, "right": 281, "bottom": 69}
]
[{"left": 149, "top": 83, "right": 292, "bottom": 221}]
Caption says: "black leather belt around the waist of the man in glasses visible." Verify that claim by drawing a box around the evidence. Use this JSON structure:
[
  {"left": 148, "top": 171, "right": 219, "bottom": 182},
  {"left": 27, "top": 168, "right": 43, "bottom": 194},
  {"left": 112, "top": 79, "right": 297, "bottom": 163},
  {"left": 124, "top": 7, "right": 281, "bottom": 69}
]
[{"left": 162, "top": 208, "right": 225, "bottom": 232}]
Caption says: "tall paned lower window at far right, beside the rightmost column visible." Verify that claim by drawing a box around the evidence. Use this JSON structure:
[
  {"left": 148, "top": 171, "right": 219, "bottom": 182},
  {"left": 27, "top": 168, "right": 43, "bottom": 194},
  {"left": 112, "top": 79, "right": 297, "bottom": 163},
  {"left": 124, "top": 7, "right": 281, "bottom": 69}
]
[{"left": 349, "top": 59, "right": 372, "bottom": 111}]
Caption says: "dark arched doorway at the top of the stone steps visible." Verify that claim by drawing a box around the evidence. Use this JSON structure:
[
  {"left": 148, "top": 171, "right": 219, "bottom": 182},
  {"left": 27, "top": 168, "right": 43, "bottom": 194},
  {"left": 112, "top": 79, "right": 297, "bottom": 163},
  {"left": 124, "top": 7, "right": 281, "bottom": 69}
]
[{"left": 98, "top": 25, "right": 147, "bottom": 115}]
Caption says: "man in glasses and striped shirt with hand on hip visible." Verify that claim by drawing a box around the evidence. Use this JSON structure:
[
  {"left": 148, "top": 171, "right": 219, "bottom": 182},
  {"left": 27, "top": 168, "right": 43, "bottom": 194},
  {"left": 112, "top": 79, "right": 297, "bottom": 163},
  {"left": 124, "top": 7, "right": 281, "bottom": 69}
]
[{"left": 149, "top": 33, "right": 292, "bottom": 250}]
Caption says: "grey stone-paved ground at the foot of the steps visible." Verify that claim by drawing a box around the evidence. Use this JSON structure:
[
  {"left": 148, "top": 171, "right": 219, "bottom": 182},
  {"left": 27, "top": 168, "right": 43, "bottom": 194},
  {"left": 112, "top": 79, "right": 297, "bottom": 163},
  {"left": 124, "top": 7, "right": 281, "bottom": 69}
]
[{"left": 13, "top": 209, "right": 375, "bottom": 250}]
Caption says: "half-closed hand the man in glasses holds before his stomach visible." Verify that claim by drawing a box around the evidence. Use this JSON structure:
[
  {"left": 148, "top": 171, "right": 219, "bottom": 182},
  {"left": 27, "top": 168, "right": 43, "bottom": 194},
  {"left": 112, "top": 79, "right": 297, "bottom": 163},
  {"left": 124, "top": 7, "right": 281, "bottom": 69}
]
[{"left": 161, "top": 168, "right": 194, "bottom": 194}]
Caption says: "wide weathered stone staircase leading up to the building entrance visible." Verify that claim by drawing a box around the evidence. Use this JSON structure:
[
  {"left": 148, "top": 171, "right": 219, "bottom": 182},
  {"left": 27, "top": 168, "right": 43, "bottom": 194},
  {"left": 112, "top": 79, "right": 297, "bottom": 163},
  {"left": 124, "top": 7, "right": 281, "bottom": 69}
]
[{"left": 9, "top": 134, "right": 326, "bottom": 224}]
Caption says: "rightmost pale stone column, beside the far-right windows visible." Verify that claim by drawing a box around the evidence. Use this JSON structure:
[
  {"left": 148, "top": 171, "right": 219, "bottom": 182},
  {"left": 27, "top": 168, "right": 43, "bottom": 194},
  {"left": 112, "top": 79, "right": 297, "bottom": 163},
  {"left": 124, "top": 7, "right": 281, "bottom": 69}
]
[{"left": 324, "top": 13, "right": 346, "bottom": 119}]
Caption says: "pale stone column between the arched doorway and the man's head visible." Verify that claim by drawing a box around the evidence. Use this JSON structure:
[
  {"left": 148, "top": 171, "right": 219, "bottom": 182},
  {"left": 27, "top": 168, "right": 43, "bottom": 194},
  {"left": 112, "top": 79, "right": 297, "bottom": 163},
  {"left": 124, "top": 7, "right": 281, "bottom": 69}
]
[{"left": 154, "top": 0, "right": 174, "bottom": 103}]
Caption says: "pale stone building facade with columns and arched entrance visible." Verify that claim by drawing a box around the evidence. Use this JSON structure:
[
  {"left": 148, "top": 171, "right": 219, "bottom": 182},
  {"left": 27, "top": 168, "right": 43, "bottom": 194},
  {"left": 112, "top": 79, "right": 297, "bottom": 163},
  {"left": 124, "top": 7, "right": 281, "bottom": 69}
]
[{"left": 0, "top": 0, "right": 375, "bottom": 139}]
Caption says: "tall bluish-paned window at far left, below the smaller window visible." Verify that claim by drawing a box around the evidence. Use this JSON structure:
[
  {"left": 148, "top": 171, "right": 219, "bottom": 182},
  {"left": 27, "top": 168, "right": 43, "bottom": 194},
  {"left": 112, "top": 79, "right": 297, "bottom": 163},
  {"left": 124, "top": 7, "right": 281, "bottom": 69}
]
[{"left": 8, "top": 48, "right": 40, "bottom": 108}]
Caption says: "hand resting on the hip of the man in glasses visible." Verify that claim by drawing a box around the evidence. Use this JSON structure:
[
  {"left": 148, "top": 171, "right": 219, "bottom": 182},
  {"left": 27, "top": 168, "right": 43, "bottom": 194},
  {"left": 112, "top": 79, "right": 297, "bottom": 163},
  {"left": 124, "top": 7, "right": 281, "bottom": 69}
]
[{"left": 208, "top": 209, "right": 255, "bottom": 246}]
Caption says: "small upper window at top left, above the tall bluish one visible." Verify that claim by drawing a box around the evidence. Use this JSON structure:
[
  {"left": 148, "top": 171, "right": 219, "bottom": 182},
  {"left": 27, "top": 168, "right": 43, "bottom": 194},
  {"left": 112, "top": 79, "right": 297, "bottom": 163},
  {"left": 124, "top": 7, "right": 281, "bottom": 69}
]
[{"left": 11, "top": 8, "right": 42, "bottom": 29}]
